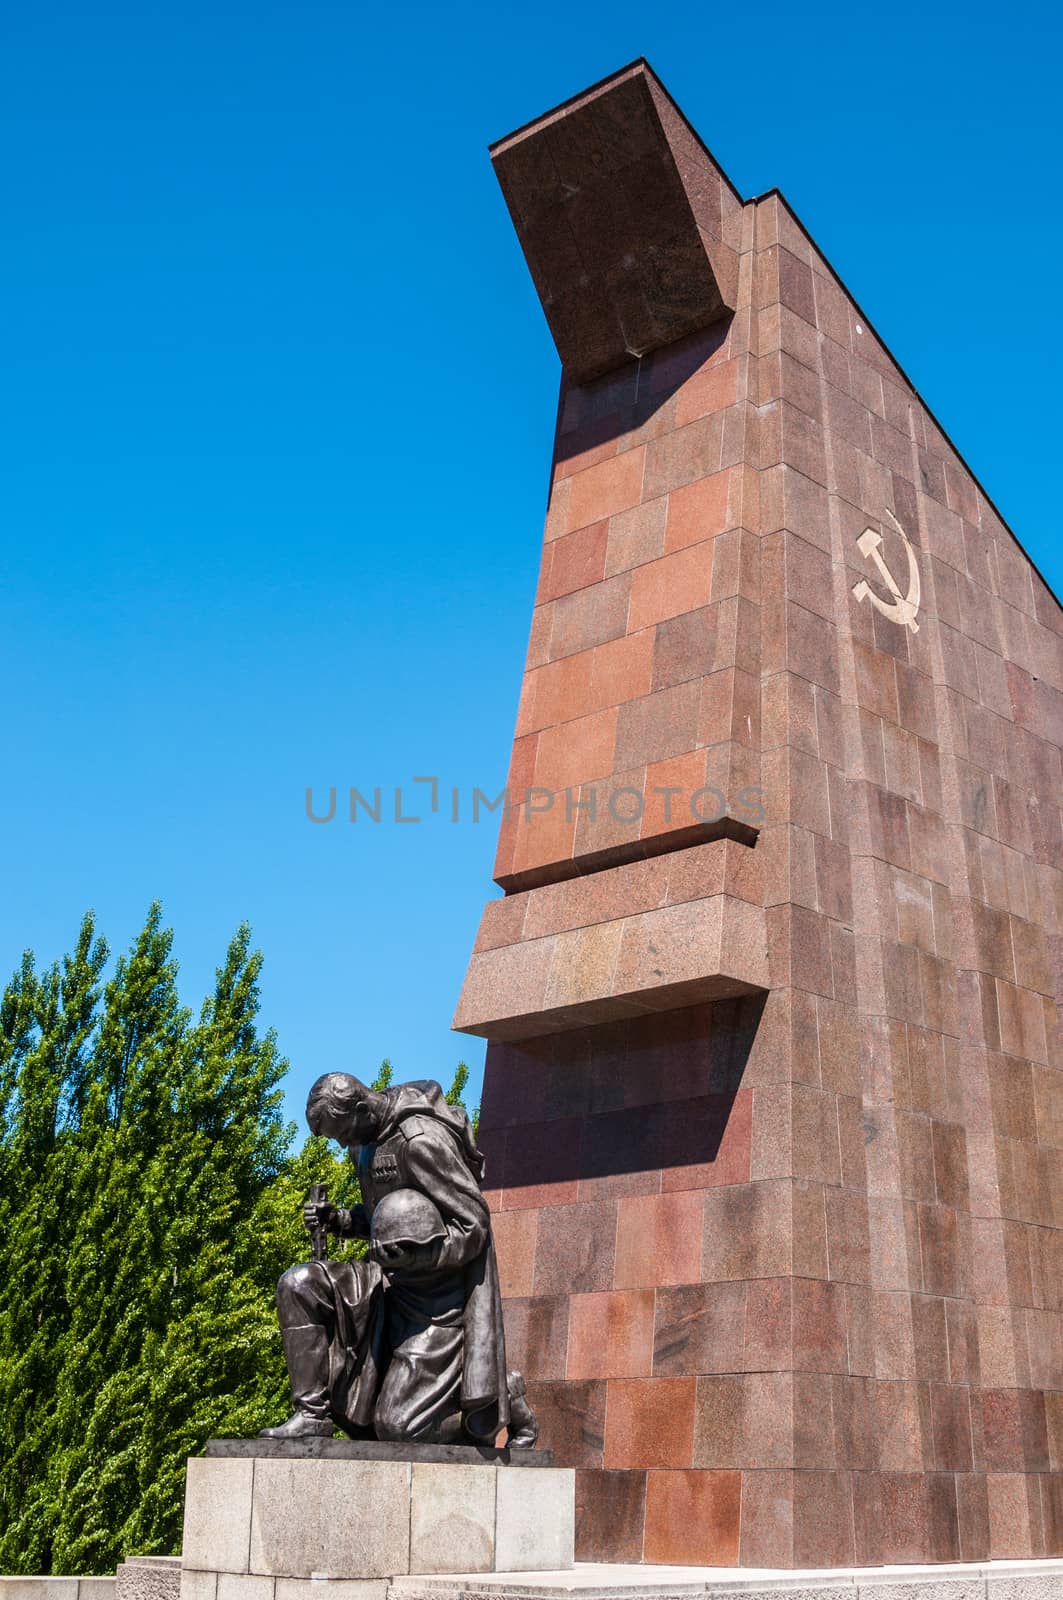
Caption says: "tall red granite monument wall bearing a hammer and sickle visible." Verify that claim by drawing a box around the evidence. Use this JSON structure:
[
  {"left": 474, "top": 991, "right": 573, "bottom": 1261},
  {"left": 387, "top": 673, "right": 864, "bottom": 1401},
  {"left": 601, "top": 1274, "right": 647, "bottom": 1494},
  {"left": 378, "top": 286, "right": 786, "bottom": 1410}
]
[{"left": 455, "top": 61, "right": 1063, "bottom": 1566}]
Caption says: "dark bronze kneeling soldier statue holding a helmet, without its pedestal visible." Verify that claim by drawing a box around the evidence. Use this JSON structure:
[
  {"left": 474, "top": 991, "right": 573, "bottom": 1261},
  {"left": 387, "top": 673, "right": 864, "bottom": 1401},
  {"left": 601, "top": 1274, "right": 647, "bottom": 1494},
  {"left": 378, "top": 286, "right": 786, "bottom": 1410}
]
[{"left": 263, "top": 1072, "right": 538, "bottom": 1446}]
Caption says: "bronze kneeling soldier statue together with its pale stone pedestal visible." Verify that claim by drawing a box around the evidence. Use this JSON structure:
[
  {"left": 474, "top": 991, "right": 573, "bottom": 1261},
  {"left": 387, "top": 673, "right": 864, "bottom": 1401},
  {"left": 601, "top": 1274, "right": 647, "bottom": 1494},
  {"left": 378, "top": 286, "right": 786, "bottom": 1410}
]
[{"left": 180, "top": 1072, "right": 575, "bottom": 1600}]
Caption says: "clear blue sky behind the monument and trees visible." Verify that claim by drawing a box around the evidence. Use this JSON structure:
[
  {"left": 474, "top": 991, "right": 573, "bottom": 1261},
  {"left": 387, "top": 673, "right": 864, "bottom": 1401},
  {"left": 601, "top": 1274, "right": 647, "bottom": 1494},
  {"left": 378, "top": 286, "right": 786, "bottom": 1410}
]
[{"left": 0, "top": 0, "right": 1063, "bottom": 1112}]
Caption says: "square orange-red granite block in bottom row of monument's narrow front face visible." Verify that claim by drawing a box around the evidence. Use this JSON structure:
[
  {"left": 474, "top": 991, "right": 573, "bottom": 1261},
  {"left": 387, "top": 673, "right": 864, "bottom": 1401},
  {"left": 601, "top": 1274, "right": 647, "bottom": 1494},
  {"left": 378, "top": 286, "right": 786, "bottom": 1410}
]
[{"left": 642, "top": 1470, "right": 741, "bottom": 1566}]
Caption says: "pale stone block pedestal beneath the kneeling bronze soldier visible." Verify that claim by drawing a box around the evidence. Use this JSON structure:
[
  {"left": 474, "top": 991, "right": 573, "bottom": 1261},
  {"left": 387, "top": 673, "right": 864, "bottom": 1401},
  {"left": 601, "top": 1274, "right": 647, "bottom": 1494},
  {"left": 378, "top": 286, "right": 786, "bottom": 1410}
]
[{"left": 181, "top": 1440, "right": 575, "bottom": 1600}]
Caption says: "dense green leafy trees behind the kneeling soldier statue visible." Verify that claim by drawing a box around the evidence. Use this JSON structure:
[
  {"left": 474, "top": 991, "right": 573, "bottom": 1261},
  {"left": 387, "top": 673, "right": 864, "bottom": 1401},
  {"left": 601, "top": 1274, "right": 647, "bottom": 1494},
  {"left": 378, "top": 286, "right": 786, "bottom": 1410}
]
[{"left": 0, "top": 906, "right": 467, "bottom": 1573}]
